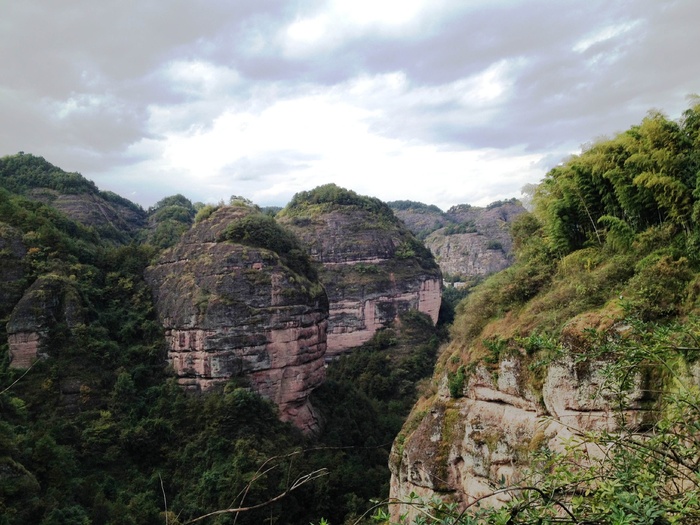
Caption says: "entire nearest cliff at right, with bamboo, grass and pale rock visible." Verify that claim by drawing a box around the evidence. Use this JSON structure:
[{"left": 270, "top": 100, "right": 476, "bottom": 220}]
[{"left": 390, "top": 106, "right": 700, "bottom": 525}]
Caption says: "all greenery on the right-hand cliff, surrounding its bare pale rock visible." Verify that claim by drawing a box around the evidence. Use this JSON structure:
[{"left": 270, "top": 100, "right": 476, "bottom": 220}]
[{"left": 376, "top": 106, "right": 700, "bottom": 525}]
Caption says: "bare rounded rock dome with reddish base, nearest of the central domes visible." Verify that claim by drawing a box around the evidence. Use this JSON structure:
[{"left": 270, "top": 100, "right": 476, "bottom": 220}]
[{"left": 146, "top": 207, "right": 328, "bottom": 431}]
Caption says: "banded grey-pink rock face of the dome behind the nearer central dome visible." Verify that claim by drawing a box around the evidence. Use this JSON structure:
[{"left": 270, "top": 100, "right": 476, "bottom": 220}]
[{"left": 280, "top": 205, "right": 442, "bottom": 356}]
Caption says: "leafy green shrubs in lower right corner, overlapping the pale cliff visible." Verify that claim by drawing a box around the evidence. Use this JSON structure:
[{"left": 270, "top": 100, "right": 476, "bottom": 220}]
[{"left": 374, "top": 317, "right": 700, "bottom": 525}]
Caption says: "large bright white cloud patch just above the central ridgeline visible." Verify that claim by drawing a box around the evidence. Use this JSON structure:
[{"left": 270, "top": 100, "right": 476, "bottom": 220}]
[{"left": 138, "top": 72, "right": 544, "bottom": 208}]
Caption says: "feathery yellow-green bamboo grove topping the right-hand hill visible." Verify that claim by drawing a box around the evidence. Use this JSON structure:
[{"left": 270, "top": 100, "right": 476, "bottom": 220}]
[{"left": 536, "top": 106, "right": 700, "bottom": 257}]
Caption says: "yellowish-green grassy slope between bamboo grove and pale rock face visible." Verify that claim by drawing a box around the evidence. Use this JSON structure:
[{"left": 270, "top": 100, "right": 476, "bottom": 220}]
[{"left": 435, "top": 211, "right": 700, "bottom": 400}]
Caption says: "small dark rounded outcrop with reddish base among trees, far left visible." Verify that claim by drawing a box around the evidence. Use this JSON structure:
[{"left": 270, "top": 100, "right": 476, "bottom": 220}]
[{"left": 7, "top": 274, "right": 84, "bottom": 368}]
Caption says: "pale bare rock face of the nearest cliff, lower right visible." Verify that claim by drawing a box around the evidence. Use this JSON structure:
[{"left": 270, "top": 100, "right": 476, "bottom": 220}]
[{"left": 390, "top": 322, "right": 648, "bottom": 516}]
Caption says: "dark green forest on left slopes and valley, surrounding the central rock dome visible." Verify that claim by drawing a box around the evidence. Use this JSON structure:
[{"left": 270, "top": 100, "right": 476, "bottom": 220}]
[{"left": 0, "top": 154, "right": 439, "bottom": 525}]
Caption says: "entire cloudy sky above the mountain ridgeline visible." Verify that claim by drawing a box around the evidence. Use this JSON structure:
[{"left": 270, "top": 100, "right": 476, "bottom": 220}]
[{"left": 0, "top": 0, "right": 700, "bottom": 209}]
